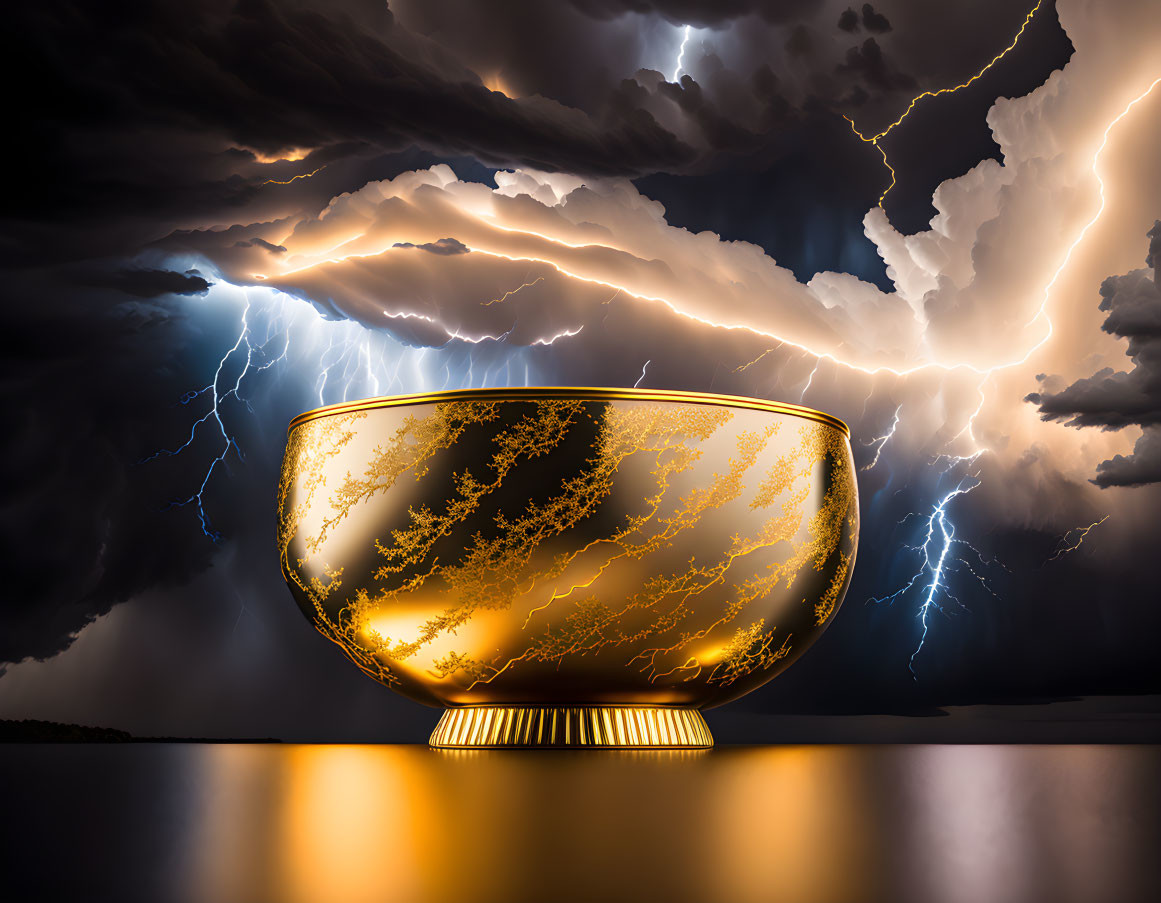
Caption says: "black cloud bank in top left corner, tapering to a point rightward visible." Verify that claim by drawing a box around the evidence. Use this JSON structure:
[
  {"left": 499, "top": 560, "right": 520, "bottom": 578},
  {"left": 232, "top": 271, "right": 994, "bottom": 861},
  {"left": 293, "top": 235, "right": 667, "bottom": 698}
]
[{"left": 0, "top": 0, "right": 697, "bottom": 262}]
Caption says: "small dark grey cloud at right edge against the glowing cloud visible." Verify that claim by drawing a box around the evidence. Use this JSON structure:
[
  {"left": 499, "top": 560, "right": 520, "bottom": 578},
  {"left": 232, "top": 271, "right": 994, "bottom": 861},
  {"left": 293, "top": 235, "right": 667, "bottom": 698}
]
[{"left": 1025, "top": 221, "right": 1161, "bottom": 486}]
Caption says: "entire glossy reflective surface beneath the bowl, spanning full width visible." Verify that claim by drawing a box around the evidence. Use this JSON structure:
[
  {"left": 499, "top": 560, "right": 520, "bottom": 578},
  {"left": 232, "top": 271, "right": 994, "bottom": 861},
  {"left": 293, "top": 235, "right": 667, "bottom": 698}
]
[{"left": 0, "top": 744, "right": 1161, "bottom": 903}]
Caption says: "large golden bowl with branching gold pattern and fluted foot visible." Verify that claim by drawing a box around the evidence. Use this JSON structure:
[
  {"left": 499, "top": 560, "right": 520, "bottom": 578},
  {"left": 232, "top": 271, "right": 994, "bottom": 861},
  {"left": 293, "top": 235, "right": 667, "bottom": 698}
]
[{"left": 277, "top": 389, "right": 858, "bottom": 747}]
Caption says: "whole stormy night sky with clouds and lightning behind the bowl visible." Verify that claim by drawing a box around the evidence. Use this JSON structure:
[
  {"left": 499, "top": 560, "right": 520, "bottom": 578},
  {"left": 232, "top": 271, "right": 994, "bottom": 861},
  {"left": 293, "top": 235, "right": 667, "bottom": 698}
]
[{"left": 0, "top": 0, "right": 1161, "bottom": 741}]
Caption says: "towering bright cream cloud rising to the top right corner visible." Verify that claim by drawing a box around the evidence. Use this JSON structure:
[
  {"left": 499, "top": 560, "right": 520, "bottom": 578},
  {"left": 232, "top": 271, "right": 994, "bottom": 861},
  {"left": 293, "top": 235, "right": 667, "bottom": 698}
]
[{"left": 864, "top": 2, "right": 1161, "bottom": 366}]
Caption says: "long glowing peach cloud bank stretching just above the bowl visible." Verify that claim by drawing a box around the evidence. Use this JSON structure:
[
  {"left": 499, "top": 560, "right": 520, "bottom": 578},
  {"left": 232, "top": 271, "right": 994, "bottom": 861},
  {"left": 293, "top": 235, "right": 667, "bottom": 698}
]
[{"left": 174, "top": 165, "right": 926, "bottom": 368}]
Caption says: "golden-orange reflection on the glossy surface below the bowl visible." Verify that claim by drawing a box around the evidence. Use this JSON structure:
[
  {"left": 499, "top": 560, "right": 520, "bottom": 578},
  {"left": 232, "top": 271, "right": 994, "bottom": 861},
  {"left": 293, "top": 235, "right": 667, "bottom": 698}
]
[{"left": 190, "top": 746, "right": 874, "bottom": 903}]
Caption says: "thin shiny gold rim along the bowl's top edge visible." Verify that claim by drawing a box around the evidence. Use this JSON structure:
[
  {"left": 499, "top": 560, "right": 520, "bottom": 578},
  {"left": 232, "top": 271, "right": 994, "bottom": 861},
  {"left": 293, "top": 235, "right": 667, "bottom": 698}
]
[{"left": 287, "top": 385, "right": 851, "bottom": 439}]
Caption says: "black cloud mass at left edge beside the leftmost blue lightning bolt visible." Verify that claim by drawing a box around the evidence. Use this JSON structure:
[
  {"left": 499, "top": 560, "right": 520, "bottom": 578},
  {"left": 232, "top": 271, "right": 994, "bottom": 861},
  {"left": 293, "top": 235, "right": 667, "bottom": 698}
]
[{"left": 0, "top": 274, "right": 219, "bottom": 663}]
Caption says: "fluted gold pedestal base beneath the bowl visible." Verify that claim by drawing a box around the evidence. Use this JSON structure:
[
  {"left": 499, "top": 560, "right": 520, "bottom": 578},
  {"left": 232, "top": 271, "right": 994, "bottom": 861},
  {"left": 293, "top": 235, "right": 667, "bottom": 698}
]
[{"left": 428, "top": 706, "right": 714, "bottom": 750}]
